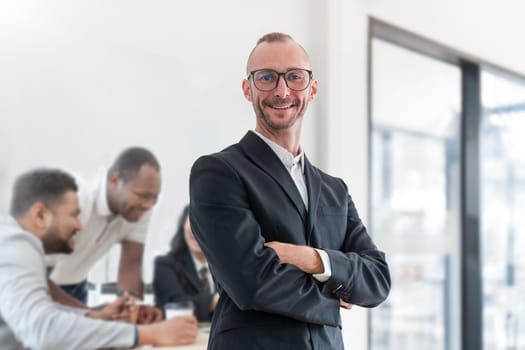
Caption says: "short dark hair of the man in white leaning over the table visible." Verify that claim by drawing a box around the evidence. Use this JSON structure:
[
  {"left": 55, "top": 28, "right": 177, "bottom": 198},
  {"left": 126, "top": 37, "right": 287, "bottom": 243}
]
[{"left": 108, "top": 147, "right": 160, "bottom": 182}]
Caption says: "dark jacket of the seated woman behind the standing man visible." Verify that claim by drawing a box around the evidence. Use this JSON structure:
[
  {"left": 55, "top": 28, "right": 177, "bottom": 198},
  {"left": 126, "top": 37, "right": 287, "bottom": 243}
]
[{"left": 153, "top": 234, "right": 213, "bottom": 322}]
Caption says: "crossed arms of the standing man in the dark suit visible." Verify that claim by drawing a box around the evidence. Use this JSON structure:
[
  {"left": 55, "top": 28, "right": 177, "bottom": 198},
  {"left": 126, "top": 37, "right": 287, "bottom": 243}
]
[{"left": 190, "top": 156, "right": 390, "bottom": 326}]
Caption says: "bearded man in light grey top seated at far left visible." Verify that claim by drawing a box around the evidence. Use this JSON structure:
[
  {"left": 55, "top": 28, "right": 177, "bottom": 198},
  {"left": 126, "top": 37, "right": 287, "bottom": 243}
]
[{"left": 0, "top": 169, "right": 197, "bottom": 350}]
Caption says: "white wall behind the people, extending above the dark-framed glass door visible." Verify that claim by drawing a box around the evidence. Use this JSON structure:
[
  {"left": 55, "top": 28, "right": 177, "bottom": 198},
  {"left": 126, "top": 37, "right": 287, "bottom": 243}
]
[{"left": 0, "top": 0, "right": 525, "bottom": 350}]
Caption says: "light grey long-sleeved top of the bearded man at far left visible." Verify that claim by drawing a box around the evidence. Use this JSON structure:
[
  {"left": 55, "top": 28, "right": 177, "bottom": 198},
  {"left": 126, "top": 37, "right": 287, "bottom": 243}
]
[{"left": 0, "top": 218, "right": 135, "bottom": 350}]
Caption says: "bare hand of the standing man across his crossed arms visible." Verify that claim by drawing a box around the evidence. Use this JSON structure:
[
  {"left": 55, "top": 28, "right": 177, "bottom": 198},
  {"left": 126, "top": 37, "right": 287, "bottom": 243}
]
[{"left": 264, "top": 241, "right": 324, "bottom": 274}]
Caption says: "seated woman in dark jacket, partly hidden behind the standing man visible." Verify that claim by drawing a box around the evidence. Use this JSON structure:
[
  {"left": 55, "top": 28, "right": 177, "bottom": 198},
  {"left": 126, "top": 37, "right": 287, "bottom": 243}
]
[{"left": 153, "top": 206, "right": 219, "bottom": 322}]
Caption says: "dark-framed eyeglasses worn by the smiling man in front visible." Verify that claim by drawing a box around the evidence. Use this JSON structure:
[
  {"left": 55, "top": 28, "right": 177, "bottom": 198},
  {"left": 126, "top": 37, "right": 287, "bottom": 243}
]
[{"left": 248, "top": 69, "right": 312, "bottom": 91}]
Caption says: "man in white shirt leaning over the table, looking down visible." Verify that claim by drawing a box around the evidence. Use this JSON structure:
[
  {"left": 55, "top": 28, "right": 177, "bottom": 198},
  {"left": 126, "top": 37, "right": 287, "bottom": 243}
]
[{"left": 48, "top": 147, "right": 161, "bottom": 317}]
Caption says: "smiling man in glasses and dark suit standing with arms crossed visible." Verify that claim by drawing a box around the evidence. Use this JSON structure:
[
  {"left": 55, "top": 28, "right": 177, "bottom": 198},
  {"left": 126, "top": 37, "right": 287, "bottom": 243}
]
[{"left": 190, "top": 33, "right": 390, "bottom": 350}]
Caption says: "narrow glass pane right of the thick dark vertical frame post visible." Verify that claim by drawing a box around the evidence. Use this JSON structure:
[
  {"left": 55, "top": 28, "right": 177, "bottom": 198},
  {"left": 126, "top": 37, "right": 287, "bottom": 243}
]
[{"left": 480, "top": 71, "right": 525, "bottom": 350}]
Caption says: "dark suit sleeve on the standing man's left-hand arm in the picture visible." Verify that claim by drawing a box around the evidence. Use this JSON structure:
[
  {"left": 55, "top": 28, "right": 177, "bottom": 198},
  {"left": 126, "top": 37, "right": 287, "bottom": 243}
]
[{"left": 190, "top": 155, "right": 339, "bottom": 326}]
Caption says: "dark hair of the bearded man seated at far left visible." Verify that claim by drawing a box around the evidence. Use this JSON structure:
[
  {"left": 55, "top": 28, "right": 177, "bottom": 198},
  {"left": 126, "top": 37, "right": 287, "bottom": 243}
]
[{"left": 9, "top": 168, "right": 78, "bottom": 218}]
